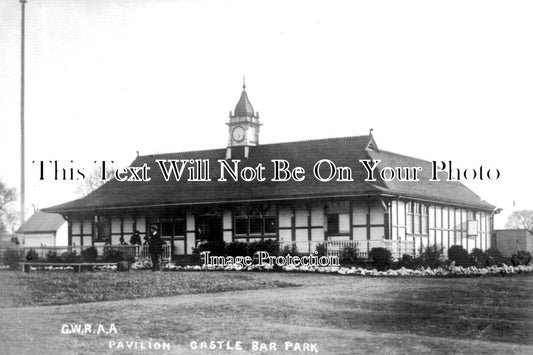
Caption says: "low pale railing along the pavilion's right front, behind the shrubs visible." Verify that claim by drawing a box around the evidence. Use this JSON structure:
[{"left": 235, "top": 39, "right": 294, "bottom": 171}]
[{"left": 281, "top": 239, "right": 415, "bottom": 259}]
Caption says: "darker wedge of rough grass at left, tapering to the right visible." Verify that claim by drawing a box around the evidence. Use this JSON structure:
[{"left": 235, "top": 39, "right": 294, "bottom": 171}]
[{"left": 0, "top": 270, "right": 299, "bottom": 308}]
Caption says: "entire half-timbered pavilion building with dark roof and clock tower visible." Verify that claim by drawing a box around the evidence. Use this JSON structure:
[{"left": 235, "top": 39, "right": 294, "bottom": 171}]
[{"left": 46, "top": 85, "right": 495, "bottom": 256}]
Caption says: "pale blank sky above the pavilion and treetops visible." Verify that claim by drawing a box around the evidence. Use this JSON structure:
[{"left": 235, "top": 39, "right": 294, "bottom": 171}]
[{"left": 0, "top": 0, "right": 533, "bottom": 228}]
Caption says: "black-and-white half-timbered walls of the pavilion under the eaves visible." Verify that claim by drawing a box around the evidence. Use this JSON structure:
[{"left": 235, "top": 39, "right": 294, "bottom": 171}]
[{"left": 69, "top": 199, "right": 491, "bottom": 255}]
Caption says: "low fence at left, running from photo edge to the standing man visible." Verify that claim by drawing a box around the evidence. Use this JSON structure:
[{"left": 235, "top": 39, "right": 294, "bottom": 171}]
[{"left": 0, "top": 244, "right": 172, "bottom": 262}]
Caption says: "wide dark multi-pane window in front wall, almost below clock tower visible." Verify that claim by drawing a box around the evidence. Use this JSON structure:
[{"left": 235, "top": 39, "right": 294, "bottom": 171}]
[{"left": 233, "top": 206, "right": 277, "bottom": 236}]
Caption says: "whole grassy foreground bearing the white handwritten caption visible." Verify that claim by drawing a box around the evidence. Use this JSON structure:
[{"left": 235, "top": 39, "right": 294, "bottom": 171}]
[{"left": 0, "top": 271, "right": 533, "bottom": 354}]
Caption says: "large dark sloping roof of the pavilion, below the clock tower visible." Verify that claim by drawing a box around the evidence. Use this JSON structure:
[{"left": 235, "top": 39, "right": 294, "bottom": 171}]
[{"left": 46, "top": 135, "right": 494, "bottom": 213}]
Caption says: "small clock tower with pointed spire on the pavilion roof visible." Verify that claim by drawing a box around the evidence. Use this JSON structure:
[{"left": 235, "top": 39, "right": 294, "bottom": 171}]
[{"left": 226, "top": 80, "right": 261, "bottom": 159}]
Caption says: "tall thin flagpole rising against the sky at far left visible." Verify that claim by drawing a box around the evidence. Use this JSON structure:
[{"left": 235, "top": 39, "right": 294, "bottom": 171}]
[{"left": 19, "top": 0, "right": 26, "bottom": 224}]
